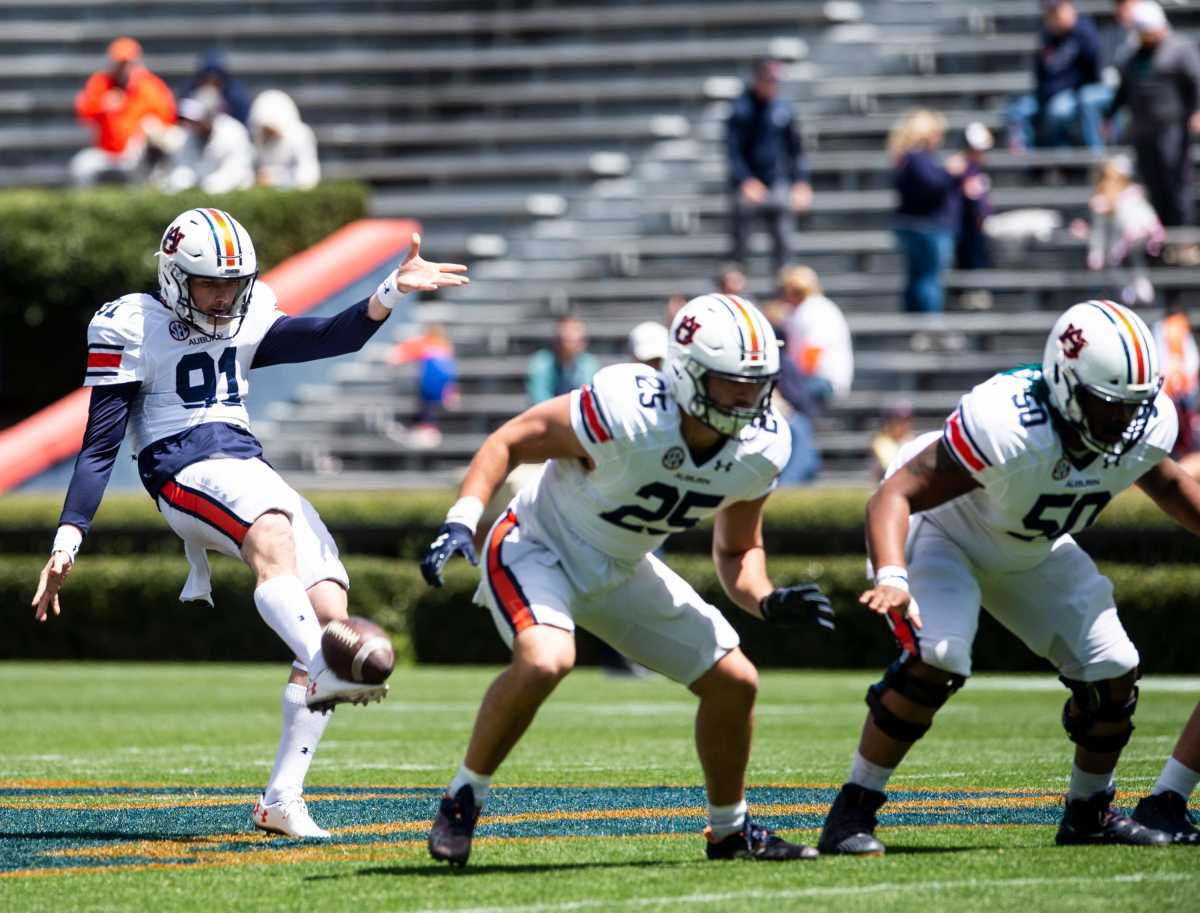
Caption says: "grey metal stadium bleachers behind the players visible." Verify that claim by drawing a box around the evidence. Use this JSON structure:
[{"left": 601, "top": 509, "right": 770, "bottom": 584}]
[{"left": 9, "top": 0, "right": 1200, "bottom": 486}]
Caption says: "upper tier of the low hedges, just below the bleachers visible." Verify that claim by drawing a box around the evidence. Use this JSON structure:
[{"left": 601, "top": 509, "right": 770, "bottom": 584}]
[{"left": 0, "top": 488, "right": 1200, "bottom": 564}]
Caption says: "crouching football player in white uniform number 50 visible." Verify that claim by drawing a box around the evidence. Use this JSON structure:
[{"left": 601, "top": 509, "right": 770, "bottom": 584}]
[{"left": 818, "top": 301, "right": 1200, "bottom": 854}]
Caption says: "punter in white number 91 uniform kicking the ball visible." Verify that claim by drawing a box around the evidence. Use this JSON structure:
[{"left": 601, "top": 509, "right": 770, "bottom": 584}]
[{"left": 34, "top": 209, "right": 467, "bottom": 837}]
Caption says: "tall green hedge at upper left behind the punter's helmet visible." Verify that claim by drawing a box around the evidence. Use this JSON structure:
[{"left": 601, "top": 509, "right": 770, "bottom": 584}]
[{"left": 0, "top": 182, "right": 368, "bottom": 414}]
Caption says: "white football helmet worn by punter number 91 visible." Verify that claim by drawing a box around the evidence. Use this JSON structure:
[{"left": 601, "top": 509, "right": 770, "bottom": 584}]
[{"left": 155, "top": 208, "right": 258, "bottom": 340}]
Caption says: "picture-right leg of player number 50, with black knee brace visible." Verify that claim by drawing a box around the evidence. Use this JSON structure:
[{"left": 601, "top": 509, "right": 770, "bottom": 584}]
[{"left": 980, "top": 536, "right": 1170, "bottom": 846}]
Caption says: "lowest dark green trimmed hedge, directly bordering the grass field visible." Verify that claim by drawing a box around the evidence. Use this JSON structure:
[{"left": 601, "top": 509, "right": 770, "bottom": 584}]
[{"left": 0, "top": 555, "right": 1200, "bottom": 673}]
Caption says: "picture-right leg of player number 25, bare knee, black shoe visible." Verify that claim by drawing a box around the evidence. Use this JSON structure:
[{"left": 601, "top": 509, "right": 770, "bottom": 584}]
[{"left": 576, "top": 555, "right": 816, "bottom": 860}]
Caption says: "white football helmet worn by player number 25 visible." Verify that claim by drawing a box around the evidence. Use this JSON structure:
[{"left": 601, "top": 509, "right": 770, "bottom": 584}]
[{"left": 664, "top": 293, "right": 779, "bottom": 438}]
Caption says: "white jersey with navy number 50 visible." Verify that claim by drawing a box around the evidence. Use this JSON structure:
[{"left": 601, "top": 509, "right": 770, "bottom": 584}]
[{"left": 888, "top": 367, "right": 1177, "bottom": 570}]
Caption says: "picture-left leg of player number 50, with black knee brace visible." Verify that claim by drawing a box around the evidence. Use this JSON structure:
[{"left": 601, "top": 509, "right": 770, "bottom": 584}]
[{"left": 817, "top": 521, "right": 979, "bottom": 855}]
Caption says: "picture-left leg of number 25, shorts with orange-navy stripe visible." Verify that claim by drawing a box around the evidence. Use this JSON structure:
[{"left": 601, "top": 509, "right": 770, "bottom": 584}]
[{"left": 428, "top": 512, "right": 575, "bottom": 865}]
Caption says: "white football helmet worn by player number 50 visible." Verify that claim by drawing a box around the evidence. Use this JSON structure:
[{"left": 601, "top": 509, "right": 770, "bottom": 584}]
[{"left": 1042, "top": 300, "right": 1163, "bottom": 456}]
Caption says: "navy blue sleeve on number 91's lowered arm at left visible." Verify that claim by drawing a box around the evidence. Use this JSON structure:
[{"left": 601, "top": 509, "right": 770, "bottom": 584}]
[{"left": 59, "top": 382, "right": 142, "bottom": 535}]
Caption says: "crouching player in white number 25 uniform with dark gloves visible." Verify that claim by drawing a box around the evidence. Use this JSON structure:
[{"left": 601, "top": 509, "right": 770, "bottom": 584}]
[{"left": 421, "top": 294, "right": 833, "bottom": 865}]
